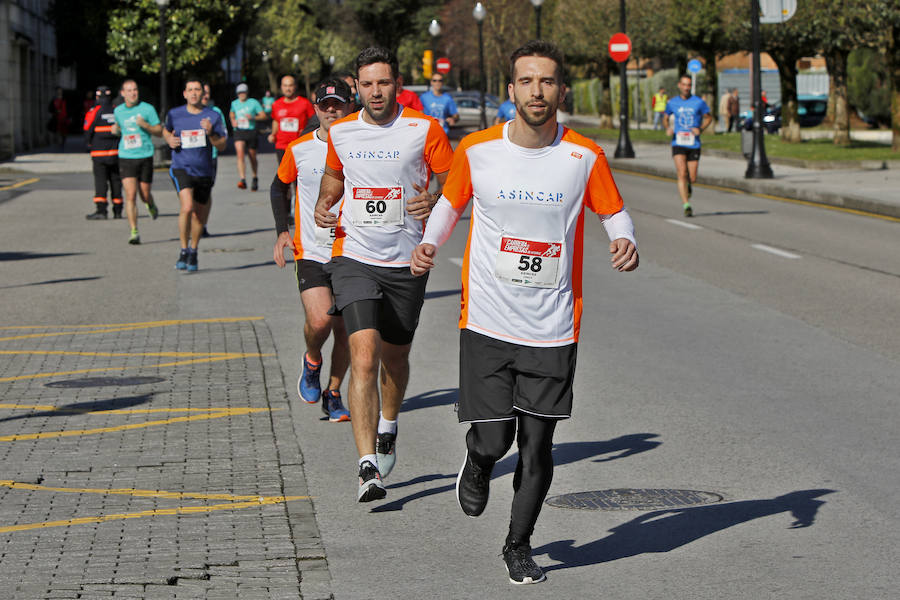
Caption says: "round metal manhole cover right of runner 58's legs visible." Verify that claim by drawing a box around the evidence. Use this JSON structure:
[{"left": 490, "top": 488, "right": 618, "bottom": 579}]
[{"left": 547, "top": 489, "right": 722, "bottom": 510}]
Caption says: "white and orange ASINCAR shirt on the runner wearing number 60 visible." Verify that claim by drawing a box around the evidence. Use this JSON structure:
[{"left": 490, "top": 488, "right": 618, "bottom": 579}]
[{"left": 327, "top": 108, "right": 453, "bottom": 267}]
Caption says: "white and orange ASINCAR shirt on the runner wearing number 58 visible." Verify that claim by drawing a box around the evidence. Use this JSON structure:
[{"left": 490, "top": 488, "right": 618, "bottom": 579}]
[{"left": 423, "top": 123, "right": 633, "bottom": 347}]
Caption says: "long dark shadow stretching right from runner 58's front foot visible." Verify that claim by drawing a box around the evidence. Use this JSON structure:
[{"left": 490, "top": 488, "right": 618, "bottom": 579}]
[{"left": 533, "top": 489, "right": 835, "bottom": 571}]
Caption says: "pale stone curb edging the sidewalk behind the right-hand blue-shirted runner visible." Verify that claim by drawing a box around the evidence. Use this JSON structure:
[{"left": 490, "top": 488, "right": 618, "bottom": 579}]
[{"left": 608, "top": 158, "right": 900, "bottom": 219}]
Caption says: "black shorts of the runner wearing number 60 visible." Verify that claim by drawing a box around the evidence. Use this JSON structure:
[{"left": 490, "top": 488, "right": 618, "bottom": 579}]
[{"left": 325, "top": 256, "right": 428, "bottom": 346}]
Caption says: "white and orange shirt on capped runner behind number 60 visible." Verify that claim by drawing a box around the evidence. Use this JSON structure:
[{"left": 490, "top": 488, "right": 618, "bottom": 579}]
[{"left": 278, "top": 130, "right": 334, "bottom": 263}]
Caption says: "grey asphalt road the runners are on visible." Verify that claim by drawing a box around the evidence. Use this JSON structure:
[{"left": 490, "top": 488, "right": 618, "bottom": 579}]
[{"left": 0, "top": 155, "right": 900, "bottom": 600}]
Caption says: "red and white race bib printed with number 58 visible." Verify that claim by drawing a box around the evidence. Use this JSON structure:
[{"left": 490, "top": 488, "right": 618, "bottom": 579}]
[{"left": 494, "top": 236, "right": 562, "bottom": 288}]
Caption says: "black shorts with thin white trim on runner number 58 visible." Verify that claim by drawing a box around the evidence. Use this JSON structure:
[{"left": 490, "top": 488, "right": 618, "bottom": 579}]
[{"left": 458, "top": 329, "right": 578, "bottom": 423}]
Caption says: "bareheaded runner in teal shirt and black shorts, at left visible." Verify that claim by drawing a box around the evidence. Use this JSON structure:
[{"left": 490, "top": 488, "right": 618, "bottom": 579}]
[{"left": 112, "top": 79, "right": 162, "bottom": 244}]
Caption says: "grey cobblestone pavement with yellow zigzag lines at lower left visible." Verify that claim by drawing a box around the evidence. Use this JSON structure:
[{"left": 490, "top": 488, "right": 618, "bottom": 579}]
[{"left": 0, "top": 318, "right": 330, "bottom": 600}]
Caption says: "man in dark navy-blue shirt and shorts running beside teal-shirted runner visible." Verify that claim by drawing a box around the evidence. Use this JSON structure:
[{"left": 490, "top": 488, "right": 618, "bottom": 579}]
[{"left": 163, "top": 79, "right": 227, "bottom": 271}]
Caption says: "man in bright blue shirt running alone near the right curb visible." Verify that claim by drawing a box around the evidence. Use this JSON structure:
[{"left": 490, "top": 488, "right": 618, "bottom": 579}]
[{"left": 663, "top": 75, "right": 712, "bottom": 217}]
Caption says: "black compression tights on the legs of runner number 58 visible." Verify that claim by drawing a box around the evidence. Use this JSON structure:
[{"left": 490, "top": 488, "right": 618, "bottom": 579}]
[{"left": 466, "top": 414, "right": 556, "bottom": 544}]
